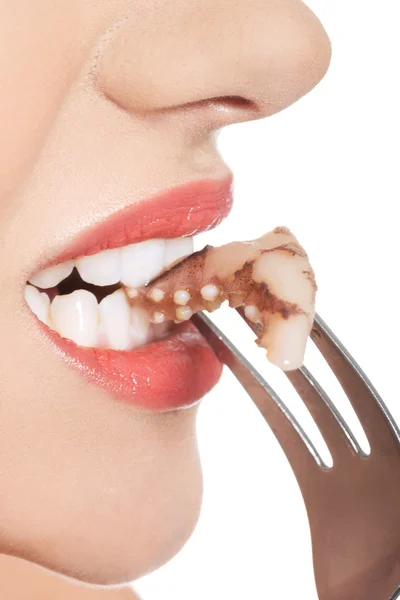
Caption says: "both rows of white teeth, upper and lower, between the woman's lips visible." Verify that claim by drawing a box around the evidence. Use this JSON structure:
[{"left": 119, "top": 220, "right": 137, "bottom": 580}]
[{"left": 25, "top": 238, "right": 193, "bottom": 350}]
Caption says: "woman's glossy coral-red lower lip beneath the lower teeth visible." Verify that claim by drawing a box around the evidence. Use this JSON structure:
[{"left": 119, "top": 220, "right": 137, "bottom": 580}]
[{"left": 43, "top": 322, "right": 222, "bottom": 412}]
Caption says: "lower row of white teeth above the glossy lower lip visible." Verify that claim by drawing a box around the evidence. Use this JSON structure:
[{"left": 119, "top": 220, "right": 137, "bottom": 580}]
[{"left": 25, "top": 284, "right": 172, "bottom": 350}]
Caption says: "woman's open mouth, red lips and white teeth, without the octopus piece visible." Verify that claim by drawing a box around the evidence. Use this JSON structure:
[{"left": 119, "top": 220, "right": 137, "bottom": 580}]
[{"left": 25, "top": 176, "right": 232, "bottom": 410}]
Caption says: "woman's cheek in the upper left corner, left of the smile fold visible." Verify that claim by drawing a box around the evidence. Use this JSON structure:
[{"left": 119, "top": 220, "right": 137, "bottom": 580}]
[{"left": 0, "top": 0, "right": 126, "bottom": 204}]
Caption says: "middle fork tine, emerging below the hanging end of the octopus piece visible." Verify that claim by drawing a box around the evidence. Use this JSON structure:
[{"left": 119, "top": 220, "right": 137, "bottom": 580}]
[{"left": 286, "top": 367, "right": 365, "bottom": 462}]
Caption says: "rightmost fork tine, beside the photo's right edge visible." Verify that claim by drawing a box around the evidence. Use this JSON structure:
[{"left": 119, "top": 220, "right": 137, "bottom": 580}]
[{"left": 311, "top": 315, "right": 400, "bottom": 451}]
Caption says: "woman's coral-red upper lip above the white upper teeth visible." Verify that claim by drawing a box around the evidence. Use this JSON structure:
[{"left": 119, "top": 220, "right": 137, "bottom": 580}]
[{"left": 35, "top": 174, "right": 236, "bottom": 272}]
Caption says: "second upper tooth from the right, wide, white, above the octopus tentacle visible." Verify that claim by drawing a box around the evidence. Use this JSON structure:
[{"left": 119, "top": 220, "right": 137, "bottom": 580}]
[{"left": 121, "top": 240, "right": 165, "bottom": 288}]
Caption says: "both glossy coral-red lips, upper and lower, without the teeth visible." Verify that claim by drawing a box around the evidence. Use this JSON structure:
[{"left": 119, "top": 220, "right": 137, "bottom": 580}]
[{"left": 31, "top": 176, "right": 232, "bottom": 411}]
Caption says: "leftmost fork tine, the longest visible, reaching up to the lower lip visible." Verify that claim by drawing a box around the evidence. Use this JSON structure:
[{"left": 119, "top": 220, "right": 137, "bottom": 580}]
[{"left": 192, "top": 313, "right": 327, "bottom": 478}]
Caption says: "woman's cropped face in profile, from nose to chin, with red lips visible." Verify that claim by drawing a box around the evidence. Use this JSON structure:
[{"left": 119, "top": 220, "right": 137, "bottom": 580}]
[{"left": 0, "top": 0, "right": 330, "bottom": 583}]
